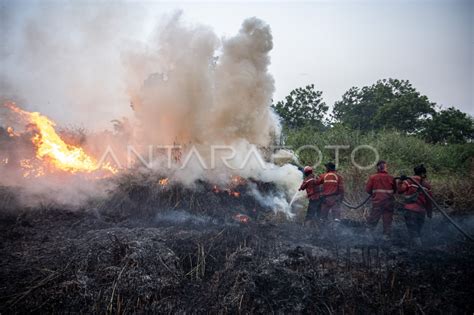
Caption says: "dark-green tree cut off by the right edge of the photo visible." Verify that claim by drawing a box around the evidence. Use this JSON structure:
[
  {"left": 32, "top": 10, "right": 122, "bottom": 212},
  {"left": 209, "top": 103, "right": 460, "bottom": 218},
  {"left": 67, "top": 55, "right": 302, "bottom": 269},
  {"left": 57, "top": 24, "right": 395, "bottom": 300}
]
[{"left": 423, "top": 107, "right": 474, "bottom": 143}]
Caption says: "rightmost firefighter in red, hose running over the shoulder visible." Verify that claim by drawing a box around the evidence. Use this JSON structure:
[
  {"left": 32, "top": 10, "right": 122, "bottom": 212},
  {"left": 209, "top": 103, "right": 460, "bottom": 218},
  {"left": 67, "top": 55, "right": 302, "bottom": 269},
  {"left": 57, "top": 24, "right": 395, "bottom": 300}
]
[{"left": 398, "top": 164, "right": 433, "bottom": 246}]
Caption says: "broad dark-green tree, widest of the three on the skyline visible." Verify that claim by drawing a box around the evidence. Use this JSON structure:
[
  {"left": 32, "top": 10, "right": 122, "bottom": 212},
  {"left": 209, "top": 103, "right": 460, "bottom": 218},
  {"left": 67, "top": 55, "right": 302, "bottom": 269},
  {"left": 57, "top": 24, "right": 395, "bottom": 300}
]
[{"left": 333, "top": 79, "right": 435, "bottom": 133}]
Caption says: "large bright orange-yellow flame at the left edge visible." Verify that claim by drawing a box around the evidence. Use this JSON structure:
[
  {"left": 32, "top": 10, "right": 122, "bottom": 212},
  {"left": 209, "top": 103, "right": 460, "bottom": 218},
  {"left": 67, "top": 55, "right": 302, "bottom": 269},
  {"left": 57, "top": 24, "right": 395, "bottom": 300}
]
[{"left": 5, "top": 102, "right": 117, "bottom": 176}]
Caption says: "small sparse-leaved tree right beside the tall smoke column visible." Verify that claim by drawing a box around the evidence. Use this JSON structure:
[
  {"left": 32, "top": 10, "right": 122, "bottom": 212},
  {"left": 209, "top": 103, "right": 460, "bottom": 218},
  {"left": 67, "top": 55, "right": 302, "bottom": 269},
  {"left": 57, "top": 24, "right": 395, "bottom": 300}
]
[{"left": 272, "top": 84, "right": 329, "bottom": 129}]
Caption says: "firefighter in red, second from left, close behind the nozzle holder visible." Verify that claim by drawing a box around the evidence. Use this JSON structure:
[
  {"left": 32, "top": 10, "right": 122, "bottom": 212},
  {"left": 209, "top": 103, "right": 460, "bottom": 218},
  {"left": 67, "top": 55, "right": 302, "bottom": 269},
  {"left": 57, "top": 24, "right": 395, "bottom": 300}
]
[{"left": 316, "top": 162, "right": 344, "bottom": 221}]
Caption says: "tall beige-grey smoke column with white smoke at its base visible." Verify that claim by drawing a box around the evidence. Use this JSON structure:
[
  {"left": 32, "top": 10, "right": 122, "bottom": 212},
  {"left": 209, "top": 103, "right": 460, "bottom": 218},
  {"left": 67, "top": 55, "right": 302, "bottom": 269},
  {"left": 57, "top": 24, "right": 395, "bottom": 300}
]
[{"left": 126, "top": 14, "right": 300, "bottom": 217}]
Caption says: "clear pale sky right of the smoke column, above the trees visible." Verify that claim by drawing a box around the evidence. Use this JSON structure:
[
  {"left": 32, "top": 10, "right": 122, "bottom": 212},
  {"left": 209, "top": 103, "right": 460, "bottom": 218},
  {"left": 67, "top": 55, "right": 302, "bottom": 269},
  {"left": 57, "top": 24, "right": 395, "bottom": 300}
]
[{"left": 168, "top": 0, "right": 474, "bottom": 115}]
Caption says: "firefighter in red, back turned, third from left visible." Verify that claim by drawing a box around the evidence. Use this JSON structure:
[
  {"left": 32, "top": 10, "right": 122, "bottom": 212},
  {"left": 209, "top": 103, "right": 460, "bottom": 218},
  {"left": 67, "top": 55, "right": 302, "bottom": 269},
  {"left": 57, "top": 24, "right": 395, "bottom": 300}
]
[{"left": 365, "top": 161, "right": 397, "bottom": 241}]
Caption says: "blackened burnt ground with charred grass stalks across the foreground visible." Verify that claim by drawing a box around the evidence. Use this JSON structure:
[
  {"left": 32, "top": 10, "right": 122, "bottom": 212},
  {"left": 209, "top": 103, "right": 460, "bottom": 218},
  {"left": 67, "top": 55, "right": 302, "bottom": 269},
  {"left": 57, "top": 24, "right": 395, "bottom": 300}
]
[{"left": 0, "top": 184, "right": 474, "bottom": 314}]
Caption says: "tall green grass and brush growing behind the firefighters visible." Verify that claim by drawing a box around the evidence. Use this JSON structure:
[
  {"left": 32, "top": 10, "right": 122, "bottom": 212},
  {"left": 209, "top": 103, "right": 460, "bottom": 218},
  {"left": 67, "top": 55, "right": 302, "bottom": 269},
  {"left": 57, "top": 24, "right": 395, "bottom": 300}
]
[{"left": 285, "top": 126, "right": 474, "bottom": 211}]
